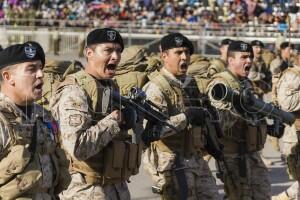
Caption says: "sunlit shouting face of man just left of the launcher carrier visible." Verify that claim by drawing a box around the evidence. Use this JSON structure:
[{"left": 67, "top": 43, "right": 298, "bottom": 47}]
[{"left": 161, "top": 47, "right": 191, "bottom": 78}]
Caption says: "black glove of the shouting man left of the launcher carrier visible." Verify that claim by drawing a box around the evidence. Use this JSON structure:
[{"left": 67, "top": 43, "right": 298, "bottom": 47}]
[{"left": 184, "top": 107, "right": 206, "bottom": 126}]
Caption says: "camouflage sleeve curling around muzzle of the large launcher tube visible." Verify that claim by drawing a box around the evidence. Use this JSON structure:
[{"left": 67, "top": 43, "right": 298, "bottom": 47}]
[{"left": 207, "top": 79, "right": 238, "bottom": 131}]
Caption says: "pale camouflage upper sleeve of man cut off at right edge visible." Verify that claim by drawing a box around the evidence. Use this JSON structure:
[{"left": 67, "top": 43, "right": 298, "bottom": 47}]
[{"left": 277, "top": 72, "right": 300, "bottom": 112}]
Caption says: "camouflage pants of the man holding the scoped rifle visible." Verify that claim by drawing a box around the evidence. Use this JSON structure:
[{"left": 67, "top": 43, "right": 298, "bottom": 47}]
[{"left": 59, "top": 173, "right": 130, "bottom": 200}]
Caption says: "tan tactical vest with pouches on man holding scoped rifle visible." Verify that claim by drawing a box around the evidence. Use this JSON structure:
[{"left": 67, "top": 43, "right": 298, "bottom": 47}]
[{"left": 58, "top": 70, "right": 142, "bottom": 186}]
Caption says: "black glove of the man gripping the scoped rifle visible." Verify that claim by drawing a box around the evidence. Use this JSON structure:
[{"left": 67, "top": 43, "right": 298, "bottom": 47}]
[{"left": 120, "top": 107, "right": 138, "bottom": 130}]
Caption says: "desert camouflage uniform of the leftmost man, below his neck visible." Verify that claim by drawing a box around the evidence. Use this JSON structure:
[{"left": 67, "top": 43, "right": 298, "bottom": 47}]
[{"left": 0, "top": 93, "right": 60, "bottom": 200}]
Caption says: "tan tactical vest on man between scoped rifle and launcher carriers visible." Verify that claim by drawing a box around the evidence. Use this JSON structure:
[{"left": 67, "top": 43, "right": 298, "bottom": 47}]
[{"left": 149, "top": 72, "right": 204, "bottom": 157}]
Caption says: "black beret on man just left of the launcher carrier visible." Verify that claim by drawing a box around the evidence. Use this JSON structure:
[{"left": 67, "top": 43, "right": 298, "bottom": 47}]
[{"left": 160, "top": 33, "right": 194, "bottom": 54}]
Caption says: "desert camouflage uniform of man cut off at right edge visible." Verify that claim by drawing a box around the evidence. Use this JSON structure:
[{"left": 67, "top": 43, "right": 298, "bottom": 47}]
[{"left": 277, "top": 66, "right": 300, "bottom": 199}]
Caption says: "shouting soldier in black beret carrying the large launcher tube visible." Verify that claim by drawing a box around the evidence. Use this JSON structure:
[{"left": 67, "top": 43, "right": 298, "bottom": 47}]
[{"left": 208, "top": 41, "right": 271, "bottom": 200}]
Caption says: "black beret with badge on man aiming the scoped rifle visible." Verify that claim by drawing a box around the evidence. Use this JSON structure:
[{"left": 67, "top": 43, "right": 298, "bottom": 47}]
[{"left": 86, "top": 28, "right": 124, "bottom": 51}]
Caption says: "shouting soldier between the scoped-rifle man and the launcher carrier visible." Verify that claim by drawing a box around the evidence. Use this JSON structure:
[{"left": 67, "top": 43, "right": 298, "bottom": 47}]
[{"left": 143, "top": 33, "right": 218, "bottom": 200}]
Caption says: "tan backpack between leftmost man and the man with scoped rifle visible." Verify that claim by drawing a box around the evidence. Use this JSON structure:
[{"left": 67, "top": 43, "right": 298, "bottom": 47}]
[{"left": 37, "top": 59, "right": 83, "bottom": 110}]
